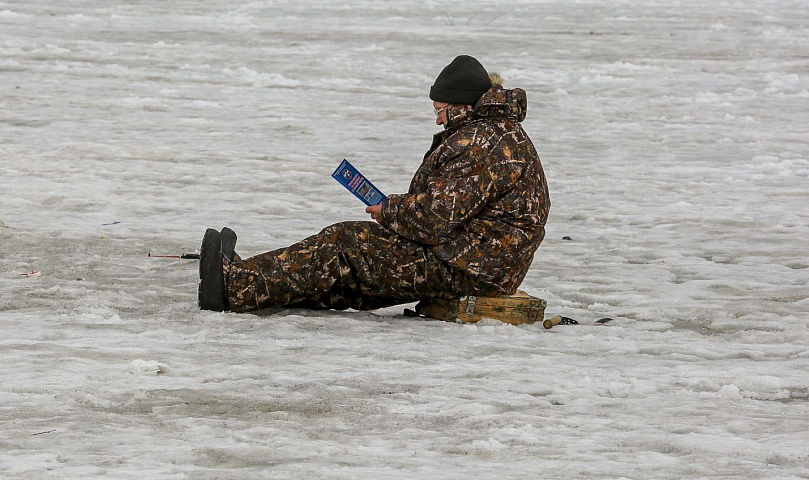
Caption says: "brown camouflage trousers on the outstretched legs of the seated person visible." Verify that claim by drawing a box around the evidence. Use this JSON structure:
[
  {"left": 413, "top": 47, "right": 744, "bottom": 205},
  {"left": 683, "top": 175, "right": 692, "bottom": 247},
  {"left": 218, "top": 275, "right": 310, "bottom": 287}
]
[{"left": 226, "top": 222, "right": 466, "bottom": 312}]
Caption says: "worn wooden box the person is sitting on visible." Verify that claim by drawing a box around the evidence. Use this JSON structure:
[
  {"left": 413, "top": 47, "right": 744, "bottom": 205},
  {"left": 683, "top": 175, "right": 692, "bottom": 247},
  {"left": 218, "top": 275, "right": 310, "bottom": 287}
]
[{"left": 406, "top": 290, "right": 547, "bottom": 325}]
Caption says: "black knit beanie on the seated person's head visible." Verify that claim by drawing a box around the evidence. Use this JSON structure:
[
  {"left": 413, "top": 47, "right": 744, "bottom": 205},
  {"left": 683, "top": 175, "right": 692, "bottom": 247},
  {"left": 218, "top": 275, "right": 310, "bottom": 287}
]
[{"left": 430, "top": 55, "right": 492, "bottom": 105}]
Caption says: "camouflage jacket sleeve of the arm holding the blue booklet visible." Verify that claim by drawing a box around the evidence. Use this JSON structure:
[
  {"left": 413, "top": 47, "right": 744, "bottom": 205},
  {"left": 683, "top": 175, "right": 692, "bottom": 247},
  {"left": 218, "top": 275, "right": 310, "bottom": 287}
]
[{"left": 382, "top": 147, "right": 522, "bottom": 245}]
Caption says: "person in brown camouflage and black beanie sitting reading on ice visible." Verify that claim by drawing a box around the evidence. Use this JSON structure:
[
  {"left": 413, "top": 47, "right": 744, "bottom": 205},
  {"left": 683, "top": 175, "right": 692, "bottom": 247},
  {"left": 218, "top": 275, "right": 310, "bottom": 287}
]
[{"left": 199, "top": 55, "right": 550, "bottom": 312}]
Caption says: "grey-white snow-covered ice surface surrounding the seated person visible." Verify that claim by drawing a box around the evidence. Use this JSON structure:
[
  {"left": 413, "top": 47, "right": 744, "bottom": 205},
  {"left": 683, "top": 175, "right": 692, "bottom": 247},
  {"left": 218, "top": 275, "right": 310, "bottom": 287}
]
[{"left": 0, "top": 0, "right": 809, "bottom": 479}]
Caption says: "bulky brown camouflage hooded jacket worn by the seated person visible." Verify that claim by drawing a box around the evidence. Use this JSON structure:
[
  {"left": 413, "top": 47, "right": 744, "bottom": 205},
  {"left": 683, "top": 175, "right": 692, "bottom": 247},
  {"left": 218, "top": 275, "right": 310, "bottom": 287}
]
[{"left": 382, "top": 85, "right": 550, "bottom": 295}]
